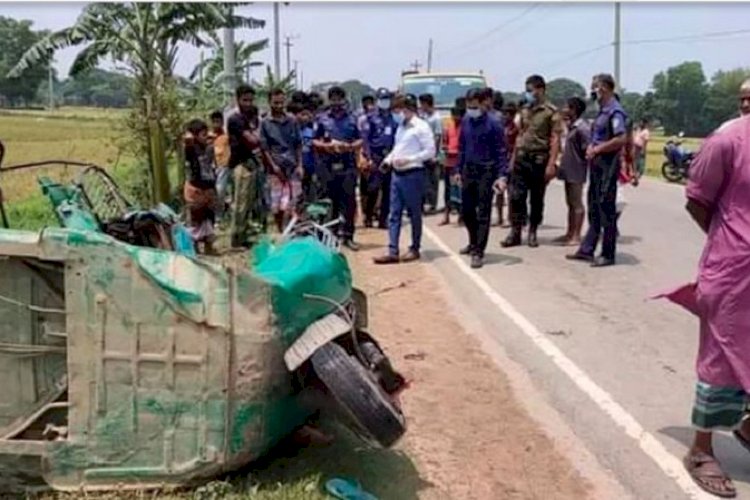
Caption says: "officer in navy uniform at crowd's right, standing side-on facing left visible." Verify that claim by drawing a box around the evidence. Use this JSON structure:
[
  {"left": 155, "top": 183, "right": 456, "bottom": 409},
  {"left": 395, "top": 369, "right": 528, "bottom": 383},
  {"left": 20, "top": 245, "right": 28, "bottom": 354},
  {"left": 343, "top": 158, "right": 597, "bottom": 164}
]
[{"left": 568, "top": 74, "right": 627, "bottom": 267}]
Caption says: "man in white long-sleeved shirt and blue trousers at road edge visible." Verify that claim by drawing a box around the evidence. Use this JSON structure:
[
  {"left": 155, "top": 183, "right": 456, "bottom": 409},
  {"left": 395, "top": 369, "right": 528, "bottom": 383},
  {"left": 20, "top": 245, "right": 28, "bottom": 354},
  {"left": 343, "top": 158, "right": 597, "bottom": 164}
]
[{"left": 375, "top": 94, "right": 435, "bottom": 264}]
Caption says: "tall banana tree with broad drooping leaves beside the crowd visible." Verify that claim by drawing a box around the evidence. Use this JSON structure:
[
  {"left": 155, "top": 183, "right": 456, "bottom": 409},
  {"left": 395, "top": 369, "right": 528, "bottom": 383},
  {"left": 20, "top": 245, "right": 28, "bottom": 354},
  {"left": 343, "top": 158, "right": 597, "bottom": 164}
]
[{"left": 9, "top": 2, "right": 265, "bottom": 202}]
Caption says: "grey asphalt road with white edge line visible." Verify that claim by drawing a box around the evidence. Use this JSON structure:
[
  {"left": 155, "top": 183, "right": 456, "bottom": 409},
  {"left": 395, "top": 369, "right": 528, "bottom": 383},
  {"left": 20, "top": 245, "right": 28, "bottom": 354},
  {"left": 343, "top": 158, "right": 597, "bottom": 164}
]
[{"left": 418, "top": 181, "right": 750, "bottom": 500}]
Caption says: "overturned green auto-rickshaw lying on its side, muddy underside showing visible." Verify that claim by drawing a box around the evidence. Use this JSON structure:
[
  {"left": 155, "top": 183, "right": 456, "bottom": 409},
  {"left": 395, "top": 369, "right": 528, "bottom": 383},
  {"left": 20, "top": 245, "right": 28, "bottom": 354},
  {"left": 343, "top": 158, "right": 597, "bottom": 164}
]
[{"left": 0, "top": 143, "right": 405, "bottom": 492}]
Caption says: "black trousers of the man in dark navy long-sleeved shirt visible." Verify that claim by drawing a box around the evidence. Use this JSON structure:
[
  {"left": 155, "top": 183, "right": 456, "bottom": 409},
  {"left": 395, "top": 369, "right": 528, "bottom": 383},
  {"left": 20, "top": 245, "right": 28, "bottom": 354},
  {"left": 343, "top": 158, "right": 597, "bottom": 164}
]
[{"left": 461, "top": 165, "right": 495, "bottom": 257}]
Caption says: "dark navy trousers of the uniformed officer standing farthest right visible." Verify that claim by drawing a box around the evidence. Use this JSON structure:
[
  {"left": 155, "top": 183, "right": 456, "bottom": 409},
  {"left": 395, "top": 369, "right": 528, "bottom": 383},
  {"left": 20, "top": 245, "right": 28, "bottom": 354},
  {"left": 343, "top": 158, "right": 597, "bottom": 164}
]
[{"left": 579, "top": 156, "right": 620, "bottom": 260}]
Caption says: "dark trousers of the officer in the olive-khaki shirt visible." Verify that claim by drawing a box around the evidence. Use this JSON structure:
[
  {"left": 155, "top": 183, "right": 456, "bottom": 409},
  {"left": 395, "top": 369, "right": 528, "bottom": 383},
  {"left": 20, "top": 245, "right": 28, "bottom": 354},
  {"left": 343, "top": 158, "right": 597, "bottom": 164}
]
[{"left": 510, "top": 151, "right": 549, "bottom": 228}]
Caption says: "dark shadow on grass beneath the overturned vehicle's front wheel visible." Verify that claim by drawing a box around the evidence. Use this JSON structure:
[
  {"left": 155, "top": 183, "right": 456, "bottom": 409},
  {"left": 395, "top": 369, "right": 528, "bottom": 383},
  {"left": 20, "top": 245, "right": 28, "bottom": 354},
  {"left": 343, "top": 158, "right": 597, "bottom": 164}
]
[{"left": 233, "top": 422, "right": 432, "bottom": 500}]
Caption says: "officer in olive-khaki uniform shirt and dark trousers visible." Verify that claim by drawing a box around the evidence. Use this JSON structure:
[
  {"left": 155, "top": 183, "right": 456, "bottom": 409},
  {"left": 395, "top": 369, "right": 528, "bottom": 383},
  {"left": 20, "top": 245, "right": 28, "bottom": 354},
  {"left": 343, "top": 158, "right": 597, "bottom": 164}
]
[{"left": 502, "top": 75, "right": 563, "bottom": 248}]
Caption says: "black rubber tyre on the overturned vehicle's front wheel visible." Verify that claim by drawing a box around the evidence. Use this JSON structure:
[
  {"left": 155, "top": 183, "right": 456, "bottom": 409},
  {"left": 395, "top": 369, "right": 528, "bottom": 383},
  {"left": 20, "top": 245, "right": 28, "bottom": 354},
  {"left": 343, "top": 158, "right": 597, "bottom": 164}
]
[{"left": 312, "top": 342, "right": 406, "bottom": 448}]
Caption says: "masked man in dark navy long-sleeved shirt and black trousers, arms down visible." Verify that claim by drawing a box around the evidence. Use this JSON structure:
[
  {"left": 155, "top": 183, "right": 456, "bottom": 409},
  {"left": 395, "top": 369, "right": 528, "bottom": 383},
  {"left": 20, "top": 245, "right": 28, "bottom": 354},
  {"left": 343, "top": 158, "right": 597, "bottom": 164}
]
[{"left": 456, "top": 89, "right": 508, "bottom": 268}]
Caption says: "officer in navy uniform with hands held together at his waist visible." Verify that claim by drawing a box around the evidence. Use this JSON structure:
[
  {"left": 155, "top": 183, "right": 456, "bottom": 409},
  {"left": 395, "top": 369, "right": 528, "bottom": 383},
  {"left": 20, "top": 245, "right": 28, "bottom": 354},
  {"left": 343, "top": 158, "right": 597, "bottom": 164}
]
[{"left": 313, "top": 87, "right": 362, "bottom": 251}]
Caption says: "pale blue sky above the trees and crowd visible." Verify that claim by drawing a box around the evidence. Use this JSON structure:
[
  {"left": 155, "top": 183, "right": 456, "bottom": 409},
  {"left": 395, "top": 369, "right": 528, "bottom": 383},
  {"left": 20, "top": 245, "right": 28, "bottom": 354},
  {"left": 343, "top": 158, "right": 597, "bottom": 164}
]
[{"left": 0, "top": 2, "right": 750, "bottom": 91}]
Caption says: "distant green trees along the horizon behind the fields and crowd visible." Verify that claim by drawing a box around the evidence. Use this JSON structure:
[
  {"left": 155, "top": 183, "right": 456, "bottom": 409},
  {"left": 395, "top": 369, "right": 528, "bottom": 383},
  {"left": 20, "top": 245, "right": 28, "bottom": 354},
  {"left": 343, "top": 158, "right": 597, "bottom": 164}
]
[{"left": 0, "top": 16, "right": 750, "bottom": 137}]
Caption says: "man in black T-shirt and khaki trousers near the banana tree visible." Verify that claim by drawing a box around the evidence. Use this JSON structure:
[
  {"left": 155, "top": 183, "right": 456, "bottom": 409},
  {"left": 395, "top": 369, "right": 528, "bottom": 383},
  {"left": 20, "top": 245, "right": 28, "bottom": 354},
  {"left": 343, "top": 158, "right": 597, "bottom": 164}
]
[{"left": 227, "top": 85, "right": 265, "bottom": 248}]
